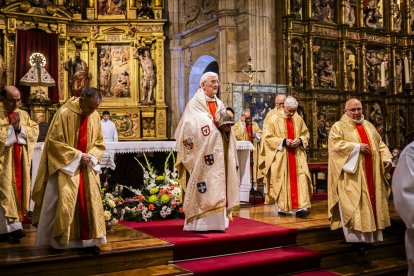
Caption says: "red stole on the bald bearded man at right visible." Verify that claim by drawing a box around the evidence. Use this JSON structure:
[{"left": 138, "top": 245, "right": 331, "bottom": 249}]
[{"left": 356, "top": 124, "right": 377, "bottom": 220}]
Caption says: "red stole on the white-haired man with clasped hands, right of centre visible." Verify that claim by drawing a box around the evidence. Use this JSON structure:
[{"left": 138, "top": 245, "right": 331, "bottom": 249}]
[{"left": 286, "top": 118, "right": 299, "bottom": 209}]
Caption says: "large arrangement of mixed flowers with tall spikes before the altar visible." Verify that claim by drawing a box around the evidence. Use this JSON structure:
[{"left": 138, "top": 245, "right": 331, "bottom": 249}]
[{"left": 123, "top": 151, "right": 184, "bottom": 221}]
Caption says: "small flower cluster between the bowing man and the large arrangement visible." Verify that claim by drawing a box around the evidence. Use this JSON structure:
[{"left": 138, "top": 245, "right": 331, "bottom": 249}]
[{"left": 101, "top": 186, "right": 124, "bottom": 226}]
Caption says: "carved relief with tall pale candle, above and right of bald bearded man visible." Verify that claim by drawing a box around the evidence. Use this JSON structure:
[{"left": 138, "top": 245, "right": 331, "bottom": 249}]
[{"left": 365, "top": 48, "right": 389, "bottom": 93}]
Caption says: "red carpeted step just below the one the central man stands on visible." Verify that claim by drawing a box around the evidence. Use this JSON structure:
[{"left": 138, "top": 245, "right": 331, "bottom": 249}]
[{"left": 175, "top": 246, "right": 321, "bottom": 276}]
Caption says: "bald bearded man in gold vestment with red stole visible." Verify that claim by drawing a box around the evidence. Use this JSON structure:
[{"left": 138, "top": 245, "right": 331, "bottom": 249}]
[{"left": 328, "top": 99, "right": 392, "bottom": 255}]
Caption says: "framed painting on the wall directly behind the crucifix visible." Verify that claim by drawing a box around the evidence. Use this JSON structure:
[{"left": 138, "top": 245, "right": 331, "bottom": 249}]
[{"left": 232, "top": 83, "right": 286, "bottom": 128}]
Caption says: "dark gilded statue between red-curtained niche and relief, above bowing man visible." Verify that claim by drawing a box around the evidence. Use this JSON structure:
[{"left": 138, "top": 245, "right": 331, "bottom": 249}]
[{"left": 65, "top": 51, "right": 90, "bottom": 97}]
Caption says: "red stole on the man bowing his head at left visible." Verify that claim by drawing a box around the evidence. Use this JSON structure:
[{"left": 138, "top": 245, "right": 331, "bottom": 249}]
[{"left": 76, "top": 115, "right": 90, "bottom": 240}]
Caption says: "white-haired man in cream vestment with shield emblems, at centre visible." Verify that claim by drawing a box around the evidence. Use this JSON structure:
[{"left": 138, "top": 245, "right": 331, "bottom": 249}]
[{"left": 175, "top": 72, "right": 240, "bottom": 231}]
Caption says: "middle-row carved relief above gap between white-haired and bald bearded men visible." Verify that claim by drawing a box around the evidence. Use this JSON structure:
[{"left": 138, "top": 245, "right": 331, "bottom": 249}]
[{"left": 312, "top": 39, "right": 338, "bottom": 89}]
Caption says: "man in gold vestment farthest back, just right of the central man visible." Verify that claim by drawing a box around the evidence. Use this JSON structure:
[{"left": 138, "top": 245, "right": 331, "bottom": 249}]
[{"left": 233, "top": 109, "right": 262, "bottom": 183}]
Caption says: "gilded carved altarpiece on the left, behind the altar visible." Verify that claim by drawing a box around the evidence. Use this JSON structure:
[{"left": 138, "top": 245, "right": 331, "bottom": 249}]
[{"left": 0, "top": 0, "right": 167, "bottom": 140}]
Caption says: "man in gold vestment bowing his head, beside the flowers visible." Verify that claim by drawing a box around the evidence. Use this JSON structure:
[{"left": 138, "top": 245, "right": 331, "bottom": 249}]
[{"left": 33, "top": 87, "right": 106, "bottom": 253}]
